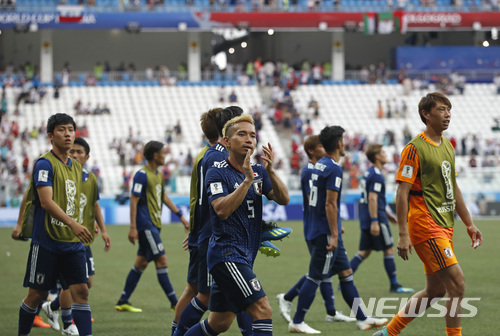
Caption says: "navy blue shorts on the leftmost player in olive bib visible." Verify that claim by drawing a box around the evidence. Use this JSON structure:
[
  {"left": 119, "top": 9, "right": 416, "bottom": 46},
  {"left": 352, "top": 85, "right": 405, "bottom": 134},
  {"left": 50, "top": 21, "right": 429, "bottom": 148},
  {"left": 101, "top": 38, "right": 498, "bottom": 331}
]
[{"left": 24, "top": 244, "right": 89, "bottom": 291}]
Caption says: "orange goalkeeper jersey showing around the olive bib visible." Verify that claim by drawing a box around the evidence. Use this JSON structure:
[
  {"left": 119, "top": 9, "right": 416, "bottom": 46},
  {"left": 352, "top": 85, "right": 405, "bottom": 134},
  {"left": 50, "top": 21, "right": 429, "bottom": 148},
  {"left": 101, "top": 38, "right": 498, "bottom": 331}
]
[{"left": 396, "top": 132, "right": 453, "bottom": 245}]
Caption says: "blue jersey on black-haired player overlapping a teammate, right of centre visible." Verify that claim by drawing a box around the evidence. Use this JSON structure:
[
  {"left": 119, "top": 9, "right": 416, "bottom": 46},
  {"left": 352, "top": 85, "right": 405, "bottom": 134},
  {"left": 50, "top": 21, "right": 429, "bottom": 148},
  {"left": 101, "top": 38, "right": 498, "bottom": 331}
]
[{"left": 306, "top": 156, "right": 342, "bottom": 241}]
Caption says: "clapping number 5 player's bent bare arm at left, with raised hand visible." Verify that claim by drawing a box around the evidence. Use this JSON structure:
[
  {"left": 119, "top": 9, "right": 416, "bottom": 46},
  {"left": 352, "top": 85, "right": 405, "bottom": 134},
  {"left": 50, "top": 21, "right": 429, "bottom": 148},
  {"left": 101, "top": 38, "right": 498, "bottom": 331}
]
[{"left": 211, "top": 151, "right": 253, "bottom": 220}]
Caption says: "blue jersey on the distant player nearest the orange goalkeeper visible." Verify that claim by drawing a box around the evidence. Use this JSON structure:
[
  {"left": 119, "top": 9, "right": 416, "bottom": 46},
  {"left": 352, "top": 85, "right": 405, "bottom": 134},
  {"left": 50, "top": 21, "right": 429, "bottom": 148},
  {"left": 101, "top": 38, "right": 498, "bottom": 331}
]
[{"left": 359, "top": 166, "right": 388, "bottom": 230}]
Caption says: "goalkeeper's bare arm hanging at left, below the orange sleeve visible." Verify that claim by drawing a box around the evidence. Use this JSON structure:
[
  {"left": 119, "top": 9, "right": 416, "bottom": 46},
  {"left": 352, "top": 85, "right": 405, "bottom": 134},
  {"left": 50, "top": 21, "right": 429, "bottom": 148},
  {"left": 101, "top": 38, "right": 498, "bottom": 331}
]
[{"left": 396, "top": 182, "right": 412, "bottom": 260}]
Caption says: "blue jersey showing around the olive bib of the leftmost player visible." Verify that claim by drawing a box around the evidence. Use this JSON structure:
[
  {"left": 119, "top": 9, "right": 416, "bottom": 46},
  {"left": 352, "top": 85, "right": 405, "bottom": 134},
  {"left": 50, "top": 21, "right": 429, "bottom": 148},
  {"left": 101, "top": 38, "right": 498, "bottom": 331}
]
[{"left": 32, "top": 151, "right": 84, "bottom": 253}]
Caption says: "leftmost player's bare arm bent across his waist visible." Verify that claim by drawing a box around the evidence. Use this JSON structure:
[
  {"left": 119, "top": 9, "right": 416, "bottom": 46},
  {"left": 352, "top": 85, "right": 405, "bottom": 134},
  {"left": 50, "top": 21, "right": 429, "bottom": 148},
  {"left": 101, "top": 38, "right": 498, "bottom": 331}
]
[{"left": 37, "top": 186, "right": 94, "bottom": 243}]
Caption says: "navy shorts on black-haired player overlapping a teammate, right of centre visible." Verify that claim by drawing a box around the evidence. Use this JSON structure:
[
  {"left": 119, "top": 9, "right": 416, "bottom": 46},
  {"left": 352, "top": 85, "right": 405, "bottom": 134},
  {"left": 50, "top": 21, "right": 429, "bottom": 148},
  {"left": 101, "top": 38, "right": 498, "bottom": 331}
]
[{"left": 308, "top": 235, "right": 351, "bottom": 281}]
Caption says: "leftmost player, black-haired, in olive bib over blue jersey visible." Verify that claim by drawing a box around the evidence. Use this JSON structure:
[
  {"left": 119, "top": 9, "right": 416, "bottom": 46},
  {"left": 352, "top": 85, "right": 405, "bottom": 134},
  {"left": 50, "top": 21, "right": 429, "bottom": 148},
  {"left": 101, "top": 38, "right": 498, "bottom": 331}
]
[{"left": 19, "top": 113, "right": 93, "bottom": 336}]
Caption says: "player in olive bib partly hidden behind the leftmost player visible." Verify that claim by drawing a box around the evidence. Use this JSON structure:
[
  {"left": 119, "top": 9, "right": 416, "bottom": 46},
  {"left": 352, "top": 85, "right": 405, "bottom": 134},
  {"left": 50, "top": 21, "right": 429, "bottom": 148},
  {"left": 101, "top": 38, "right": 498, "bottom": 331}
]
[{"left": 42, "top": 138, "right": 111, "bottom": 335}]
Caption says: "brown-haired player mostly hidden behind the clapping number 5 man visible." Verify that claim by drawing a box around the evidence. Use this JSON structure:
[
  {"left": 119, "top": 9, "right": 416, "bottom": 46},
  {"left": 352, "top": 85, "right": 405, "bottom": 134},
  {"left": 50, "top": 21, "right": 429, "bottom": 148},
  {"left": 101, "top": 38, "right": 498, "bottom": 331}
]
[{"left": 172, "top": 108, "right": 222, "bottom": 335}]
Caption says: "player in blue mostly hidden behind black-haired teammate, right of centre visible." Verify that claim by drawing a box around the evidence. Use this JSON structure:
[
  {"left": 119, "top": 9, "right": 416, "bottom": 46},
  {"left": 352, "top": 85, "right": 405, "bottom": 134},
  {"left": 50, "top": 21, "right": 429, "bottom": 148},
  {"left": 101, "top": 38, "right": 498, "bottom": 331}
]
[{"left": 277, "top": 135, "right": 356, "bottom": 323}]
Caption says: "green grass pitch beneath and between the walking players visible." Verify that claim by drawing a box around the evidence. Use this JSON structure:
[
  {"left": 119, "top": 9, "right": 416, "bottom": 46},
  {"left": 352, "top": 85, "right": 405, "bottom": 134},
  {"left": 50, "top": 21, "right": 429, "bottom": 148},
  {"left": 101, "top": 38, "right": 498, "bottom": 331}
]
[{"left": 0, "top": 220, "right": 500, "bottom": 336}]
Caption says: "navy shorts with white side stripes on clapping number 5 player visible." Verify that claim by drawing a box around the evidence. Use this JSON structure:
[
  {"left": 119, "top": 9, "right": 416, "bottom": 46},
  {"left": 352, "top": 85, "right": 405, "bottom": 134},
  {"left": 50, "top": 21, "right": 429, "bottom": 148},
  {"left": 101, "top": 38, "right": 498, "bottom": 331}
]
[{"left": 208, "top": 262, "right": 266, "bottom": 313}]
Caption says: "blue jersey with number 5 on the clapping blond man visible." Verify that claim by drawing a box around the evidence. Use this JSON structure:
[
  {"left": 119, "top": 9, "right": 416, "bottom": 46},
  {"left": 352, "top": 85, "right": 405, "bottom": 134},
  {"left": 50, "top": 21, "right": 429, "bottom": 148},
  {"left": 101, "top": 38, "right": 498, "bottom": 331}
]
[{"left": 205, "top": 160, "right": 272, "bottom": 269}]
